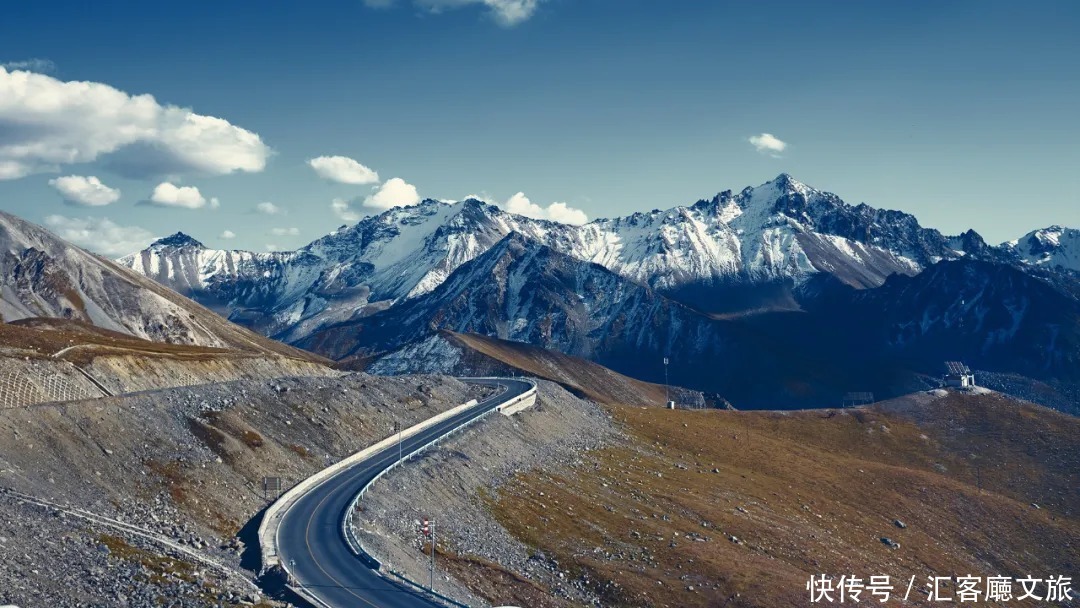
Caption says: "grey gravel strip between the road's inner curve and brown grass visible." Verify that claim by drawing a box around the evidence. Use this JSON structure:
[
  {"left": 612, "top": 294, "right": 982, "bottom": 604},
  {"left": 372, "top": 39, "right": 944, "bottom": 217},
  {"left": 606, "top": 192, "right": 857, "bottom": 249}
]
[{"left": 357, "top": 381, "right": 620, "bottom": 607}]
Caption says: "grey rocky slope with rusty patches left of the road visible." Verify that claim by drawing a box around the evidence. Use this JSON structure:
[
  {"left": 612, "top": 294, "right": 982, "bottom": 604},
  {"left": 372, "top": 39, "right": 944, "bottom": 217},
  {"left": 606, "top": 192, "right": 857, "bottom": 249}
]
[{"left": 0, "top": 374, "right": 481, "bottom": 608}]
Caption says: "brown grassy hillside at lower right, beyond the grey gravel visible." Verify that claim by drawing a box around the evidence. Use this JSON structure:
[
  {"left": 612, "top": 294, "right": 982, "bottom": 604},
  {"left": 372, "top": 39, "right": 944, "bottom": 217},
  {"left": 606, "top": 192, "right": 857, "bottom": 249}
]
[{"left": 492, "top": 393, "right": 1080, "bottom": 607}]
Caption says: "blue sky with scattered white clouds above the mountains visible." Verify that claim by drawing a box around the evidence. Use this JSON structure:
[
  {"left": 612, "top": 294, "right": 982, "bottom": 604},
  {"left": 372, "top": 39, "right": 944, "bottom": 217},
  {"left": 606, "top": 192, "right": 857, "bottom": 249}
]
[{"left": 0, "top": 0, "right": 1080, "bottom": 256}]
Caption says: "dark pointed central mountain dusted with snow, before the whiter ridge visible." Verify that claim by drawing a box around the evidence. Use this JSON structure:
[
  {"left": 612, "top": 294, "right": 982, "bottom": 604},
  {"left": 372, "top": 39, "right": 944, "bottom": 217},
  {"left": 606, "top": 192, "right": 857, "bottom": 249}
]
[{"left": 299, "top": 232, "right": 717, "bottom": 361}]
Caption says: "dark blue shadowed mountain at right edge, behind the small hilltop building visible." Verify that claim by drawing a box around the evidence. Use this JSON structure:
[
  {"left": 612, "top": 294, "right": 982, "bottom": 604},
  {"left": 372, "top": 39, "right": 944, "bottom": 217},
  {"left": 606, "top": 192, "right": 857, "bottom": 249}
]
[{"left": 807, "top": 259, "right": 1080, "bottom": 382}]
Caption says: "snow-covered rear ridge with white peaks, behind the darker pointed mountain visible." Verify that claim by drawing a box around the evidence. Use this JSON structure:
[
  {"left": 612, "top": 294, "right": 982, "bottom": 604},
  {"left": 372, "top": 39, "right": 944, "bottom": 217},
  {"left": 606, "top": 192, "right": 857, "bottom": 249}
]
[{"left": 121, "top": 174, "right": 962, "bottom": 341}]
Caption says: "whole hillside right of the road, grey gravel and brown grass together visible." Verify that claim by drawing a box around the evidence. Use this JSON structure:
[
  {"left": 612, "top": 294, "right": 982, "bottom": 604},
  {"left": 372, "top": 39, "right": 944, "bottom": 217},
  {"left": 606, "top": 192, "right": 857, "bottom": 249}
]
[{"left": 352, "top": 391, "right": 1080, "bottom": 608}]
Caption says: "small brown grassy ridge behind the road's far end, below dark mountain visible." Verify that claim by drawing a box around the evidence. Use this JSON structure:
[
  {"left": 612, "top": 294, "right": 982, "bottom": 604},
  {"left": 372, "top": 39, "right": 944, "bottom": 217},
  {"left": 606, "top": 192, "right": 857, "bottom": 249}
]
[{"left": 444, "top": 332, "right": 664, "bottom": 405}]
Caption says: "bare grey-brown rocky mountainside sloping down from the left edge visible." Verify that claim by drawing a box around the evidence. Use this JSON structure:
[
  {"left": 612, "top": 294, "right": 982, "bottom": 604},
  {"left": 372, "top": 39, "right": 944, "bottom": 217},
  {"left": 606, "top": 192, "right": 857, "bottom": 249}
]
[{"left": 0, "top": 212, "right": 321, "bottom": 359}]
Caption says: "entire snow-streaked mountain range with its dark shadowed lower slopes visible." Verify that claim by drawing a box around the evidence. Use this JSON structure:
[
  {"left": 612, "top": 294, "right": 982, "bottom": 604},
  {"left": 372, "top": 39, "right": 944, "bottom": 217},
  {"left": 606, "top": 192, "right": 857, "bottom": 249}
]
[{"left": 29, "top": 174, "right": 1080, "bottom": 406}]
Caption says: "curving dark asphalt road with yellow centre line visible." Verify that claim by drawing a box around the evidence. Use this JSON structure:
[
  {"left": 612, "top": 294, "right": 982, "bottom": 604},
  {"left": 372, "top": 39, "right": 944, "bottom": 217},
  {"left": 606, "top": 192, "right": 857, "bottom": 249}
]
[{"left": 278, "top": 379, "right": 531, "bottom": 608}]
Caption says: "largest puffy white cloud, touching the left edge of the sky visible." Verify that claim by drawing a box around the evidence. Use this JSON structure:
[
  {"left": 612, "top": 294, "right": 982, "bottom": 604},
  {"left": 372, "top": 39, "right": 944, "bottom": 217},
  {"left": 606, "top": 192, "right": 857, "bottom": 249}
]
[{"left": 0, "top": 67, "right": 271, "bottom": 179}]
